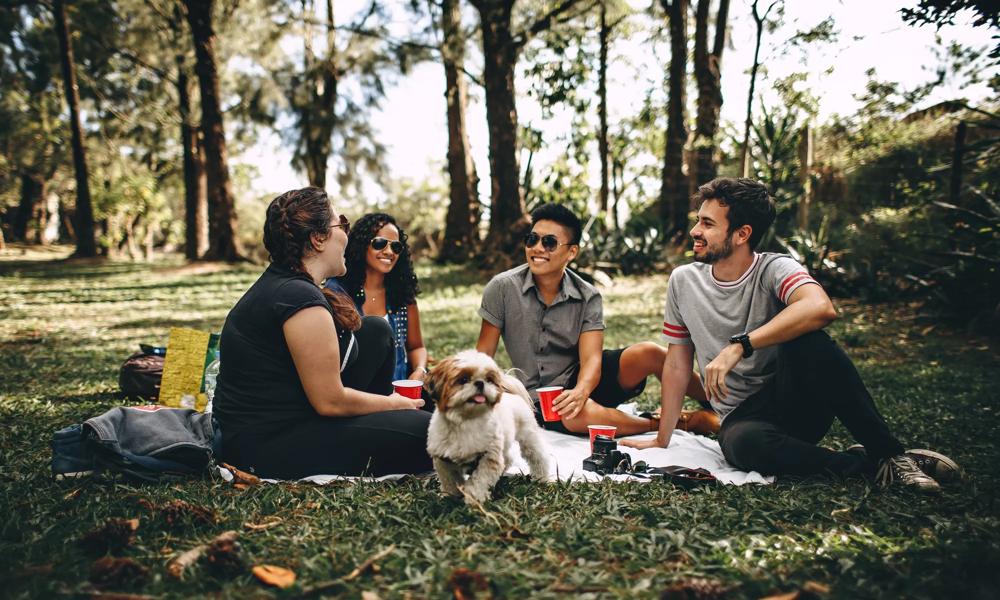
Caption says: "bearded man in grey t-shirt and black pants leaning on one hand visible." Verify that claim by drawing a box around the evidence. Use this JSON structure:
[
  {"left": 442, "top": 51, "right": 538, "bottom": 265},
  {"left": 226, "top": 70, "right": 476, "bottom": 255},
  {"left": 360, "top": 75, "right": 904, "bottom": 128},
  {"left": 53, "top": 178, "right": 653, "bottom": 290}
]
[{"left": 622, "top": 178, "right": 958, "bottom": 491}]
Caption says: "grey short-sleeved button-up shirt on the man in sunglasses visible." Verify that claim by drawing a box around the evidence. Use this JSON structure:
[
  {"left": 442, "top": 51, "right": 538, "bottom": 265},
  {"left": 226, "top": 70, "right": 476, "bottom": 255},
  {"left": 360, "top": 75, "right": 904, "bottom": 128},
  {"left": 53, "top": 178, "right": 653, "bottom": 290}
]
[{"left": 479, "top": 264, "right": 604, "bottom": 397}]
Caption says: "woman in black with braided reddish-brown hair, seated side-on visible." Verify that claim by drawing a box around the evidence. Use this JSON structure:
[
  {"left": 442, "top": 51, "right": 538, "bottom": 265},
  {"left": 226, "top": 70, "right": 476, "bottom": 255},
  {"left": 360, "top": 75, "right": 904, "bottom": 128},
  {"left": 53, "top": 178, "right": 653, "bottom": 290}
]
[{"left": 214, "top": 188, "right": 431, "bottom": 479}]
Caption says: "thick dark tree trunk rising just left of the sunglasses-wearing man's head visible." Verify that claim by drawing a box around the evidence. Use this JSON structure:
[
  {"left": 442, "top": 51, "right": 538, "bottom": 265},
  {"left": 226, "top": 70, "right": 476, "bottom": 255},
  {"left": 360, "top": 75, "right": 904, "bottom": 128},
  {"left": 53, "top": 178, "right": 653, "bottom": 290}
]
[{"left": 474, "top": 0, "right": 528, "bottom": 260}]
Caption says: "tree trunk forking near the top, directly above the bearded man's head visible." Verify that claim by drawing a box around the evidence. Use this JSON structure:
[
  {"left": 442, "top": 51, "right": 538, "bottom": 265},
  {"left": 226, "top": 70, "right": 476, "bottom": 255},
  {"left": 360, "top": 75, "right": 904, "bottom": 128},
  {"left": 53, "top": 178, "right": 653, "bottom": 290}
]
[{"left": 691, "top": 0, "right": 729, "bottom": 190}]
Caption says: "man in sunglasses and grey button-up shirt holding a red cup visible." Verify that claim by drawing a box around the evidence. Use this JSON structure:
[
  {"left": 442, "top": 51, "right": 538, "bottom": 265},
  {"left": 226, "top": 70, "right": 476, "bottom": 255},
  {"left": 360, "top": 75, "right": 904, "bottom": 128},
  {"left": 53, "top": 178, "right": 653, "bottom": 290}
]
[{"left": 476, "top": 204, "right": 703, "bottom": 435}]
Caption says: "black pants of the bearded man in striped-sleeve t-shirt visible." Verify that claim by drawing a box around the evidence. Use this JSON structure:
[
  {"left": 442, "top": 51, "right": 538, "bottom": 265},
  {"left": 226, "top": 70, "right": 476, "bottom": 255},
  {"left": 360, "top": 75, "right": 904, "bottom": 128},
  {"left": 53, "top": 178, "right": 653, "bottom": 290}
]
[{"left": 719, "top": 331, "right": 903, "bottom": 476}]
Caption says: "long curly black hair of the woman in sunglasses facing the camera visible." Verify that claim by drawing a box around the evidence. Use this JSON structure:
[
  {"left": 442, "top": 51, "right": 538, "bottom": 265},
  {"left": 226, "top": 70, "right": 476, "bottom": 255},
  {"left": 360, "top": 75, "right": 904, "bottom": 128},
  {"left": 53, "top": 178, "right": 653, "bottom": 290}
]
[{"left": 342, "top": 213, "right": 420, "bottom": 308}]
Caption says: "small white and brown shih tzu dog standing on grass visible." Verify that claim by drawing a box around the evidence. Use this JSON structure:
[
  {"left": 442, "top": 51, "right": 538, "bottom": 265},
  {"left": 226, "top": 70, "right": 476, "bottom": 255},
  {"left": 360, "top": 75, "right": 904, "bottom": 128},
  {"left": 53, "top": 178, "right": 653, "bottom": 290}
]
[{"left": 424, "top": 350, "right": 549, "bottom": 506}]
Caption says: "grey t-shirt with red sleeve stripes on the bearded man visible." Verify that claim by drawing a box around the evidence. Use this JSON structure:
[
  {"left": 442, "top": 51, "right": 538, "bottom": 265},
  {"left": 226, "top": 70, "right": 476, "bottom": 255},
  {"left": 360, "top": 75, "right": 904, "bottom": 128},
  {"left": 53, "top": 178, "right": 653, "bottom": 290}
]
[{"left": 663, "top": 252, "right": 818, "bottom": 419}]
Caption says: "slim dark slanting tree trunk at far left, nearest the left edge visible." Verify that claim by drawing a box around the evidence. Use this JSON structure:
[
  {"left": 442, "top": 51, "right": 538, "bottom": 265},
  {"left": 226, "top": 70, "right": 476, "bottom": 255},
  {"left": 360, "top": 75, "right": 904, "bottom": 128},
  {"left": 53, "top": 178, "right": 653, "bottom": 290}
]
[{"left": 52, "top": 0, "right": 97, "bottom": 257}]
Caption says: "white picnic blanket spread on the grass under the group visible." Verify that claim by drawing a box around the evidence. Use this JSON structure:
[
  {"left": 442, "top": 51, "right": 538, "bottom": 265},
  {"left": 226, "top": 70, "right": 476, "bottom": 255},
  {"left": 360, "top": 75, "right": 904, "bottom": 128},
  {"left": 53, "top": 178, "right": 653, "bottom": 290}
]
[{"left": 219, "top": 418, "right": 774, "bottom": 485}]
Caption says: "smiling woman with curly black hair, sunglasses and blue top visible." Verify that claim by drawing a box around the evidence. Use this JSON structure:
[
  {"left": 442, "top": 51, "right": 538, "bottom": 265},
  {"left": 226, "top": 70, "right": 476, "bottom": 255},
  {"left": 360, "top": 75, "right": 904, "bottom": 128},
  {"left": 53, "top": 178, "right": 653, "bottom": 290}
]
[{"left": 327, "top": 213, "right": 427, "bottom": 381}]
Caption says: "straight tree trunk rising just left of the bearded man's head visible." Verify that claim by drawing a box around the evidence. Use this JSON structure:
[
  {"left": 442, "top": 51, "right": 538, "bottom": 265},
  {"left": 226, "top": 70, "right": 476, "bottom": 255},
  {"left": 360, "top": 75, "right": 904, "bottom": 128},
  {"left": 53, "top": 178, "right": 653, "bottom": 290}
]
[{"left": 660, "top": 0, "right": 689, "bottom": 237}]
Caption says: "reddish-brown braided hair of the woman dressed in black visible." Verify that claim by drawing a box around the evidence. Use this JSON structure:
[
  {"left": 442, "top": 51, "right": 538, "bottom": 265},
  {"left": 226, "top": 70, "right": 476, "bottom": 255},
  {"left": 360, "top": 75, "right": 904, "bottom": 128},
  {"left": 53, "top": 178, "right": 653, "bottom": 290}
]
[{"left": 264, "top": 187, "right": 361, "bottom": 331}]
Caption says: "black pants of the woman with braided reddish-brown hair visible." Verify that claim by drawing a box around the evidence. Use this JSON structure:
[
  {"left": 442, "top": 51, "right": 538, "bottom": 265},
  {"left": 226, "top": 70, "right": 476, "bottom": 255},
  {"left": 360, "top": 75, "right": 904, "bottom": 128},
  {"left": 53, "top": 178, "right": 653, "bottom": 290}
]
[{"left": 224, "top": 317, "right": 432, "bottom": 479}]
